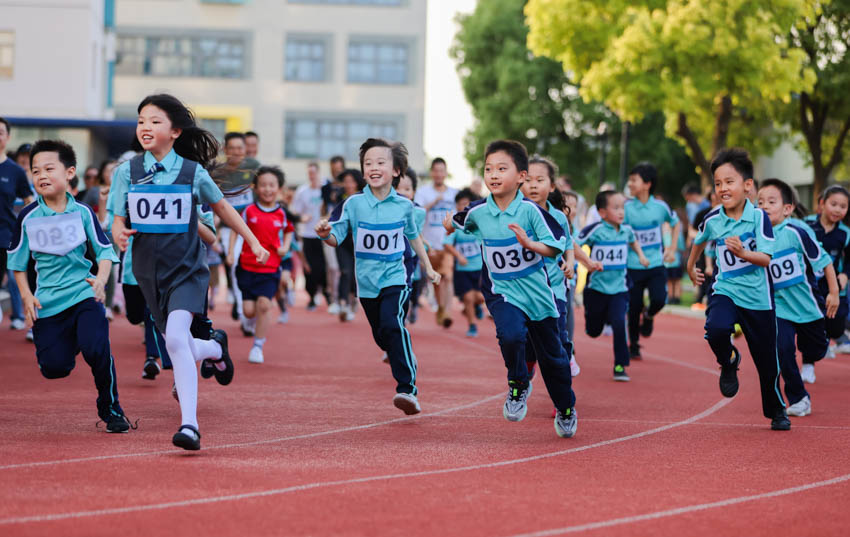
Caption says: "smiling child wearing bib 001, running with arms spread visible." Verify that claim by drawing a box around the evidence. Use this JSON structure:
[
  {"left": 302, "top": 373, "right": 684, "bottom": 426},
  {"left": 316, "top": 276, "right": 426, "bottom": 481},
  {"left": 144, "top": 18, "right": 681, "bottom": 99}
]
[{"left": 316, "top": 138, "right": 440, "bottom": 415}]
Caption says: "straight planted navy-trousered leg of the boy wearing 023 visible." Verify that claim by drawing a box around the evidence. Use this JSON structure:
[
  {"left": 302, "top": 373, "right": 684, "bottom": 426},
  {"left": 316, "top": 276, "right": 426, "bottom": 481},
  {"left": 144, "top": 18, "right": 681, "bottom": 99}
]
[{"left": 74, "top": 299, "right": 124, "bottom": 417}]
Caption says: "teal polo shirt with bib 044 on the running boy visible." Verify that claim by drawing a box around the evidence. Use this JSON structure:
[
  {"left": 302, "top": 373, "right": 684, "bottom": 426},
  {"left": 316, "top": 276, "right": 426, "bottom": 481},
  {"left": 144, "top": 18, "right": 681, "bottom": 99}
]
[{"left": 576, "top": 220, "right": 632, "bottom": 295}]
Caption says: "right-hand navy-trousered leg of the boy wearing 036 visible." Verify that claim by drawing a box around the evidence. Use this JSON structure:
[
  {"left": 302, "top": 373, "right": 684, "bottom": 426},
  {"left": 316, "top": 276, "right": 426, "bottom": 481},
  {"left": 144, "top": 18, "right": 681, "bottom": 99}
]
[{"left": 528, "top": 317, "right": 572, "bottom": 411}]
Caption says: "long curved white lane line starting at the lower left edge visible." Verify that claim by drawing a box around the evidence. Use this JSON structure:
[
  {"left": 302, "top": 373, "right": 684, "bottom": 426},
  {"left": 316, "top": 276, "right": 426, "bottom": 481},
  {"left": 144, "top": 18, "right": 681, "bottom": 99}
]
[{"left": 0, "top": 399, "right": 732, "bottom": 525}]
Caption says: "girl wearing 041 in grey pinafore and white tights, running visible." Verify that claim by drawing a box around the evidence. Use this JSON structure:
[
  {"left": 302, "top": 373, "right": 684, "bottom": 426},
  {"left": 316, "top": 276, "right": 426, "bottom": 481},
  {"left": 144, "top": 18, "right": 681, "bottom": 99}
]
[{"left": 112, "top": 94, "right": 269, "bottom": 450}]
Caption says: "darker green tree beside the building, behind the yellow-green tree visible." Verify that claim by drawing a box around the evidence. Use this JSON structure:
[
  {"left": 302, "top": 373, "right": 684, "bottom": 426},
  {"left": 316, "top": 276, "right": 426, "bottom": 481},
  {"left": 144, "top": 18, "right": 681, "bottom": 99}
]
[{"left": 451, "top": 0, "right": 695, "bottom": 200}]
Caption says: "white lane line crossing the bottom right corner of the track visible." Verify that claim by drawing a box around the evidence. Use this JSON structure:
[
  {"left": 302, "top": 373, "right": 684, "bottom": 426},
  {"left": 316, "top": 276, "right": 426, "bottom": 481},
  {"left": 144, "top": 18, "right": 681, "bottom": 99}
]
[{"left": 500, "top": 474, "right": 850, "bottom": 537}]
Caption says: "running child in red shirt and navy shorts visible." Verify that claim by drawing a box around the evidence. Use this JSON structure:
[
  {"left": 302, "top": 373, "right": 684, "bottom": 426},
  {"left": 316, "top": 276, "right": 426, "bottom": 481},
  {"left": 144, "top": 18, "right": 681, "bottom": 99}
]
[{"left": 227, "top": 166, "right": 295, "bottom": 364}]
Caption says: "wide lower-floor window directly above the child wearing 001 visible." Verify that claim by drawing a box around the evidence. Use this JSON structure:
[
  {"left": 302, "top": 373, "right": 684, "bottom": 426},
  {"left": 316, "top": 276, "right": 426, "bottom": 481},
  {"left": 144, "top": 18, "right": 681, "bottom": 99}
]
[{"left": 284, "top": 116, "right": 401, "bottom": 160}]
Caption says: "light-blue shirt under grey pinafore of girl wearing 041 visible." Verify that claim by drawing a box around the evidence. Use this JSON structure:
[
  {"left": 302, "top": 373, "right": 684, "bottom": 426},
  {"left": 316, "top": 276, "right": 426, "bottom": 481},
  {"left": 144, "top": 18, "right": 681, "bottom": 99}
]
[{"left": 109, "top": 149, "right": 224, "bottom": 216}]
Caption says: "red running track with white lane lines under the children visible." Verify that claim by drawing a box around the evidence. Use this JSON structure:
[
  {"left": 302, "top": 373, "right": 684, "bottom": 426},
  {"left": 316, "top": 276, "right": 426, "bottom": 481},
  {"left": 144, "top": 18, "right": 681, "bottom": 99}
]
[{"left": 0, "top": 300, "right": 850, "bottom": 537}]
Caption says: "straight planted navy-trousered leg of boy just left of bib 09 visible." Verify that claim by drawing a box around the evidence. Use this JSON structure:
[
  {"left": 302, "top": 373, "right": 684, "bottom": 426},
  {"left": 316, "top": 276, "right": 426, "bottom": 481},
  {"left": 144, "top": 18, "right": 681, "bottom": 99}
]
[{"left": 738, "top": 308, "right": 785, "bottom": 419}]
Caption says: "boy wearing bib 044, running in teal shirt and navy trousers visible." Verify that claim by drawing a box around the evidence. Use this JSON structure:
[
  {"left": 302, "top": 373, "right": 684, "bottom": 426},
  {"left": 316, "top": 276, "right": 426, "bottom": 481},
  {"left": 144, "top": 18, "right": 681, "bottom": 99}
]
[{"left": 576, "top": 190, "right": 648, "bottom": 382}]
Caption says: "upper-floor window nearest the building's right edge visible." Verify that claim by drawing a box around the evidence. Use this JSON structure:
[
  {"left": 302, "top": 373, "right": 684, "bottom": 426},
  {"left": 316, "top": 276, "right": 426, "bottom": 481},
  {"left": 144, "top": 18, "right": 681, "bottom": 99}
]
[{"left": 348, "top": 41, "right": 410, "bottom": 84}]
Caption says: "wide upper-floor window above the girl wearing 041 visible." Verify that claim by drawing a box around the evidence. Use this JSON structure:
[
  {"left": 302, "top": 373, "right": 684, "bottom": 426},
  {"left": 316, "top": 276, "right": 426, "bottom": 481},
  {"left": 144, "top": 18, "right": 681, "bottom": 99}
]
[{"left": 115, "top": 35, "right": 248, "bottom": 78}]
